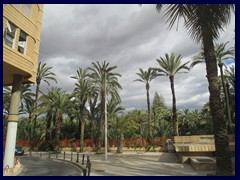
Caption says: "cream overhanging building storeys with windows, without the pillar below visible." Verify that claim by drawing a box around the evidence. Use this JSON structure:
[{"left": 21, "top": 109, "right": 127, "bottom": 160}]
[{"left": 3, "top": 4, "right": 43, "bottom": 85}]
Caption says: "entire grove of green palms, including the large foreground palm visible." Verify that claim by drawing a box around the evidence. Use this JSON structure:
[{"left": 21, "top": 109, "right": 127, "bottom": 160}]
[{"left": 3, "top": 4, "right": 235, "bottom": 175}]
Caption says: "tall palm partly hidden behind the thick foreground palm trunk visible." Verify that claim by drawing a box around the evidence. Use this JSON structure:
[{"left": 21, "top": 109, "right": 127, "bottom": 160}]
[{"left": 191, "top": 42, "right": 234, "bottom": 129}]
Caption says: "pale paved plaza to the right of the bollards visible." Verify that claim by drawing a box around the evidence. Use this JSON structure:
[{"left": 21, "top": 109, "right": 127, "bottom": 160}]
[{"left": 81, "top": 152, "right": 214, "bottom": 176}]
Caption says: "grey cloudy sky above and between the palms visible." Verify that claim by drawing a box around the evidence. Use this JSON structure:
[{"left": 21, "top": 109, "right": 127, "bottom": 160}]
[{"left": 39, "top": 4, "right": 235, "bottom": 110}]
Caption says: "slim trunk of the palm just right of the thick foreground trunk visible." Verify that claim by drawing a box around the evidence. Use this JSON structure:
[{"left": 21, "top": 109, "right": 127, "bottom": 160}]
[{"left": 219, "top": 64, "right": 232, "bottom": 132}]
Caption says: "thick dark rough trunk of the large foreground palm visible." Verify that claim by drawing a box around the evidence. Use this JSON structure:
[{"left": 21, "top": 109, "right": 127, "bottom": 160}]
[{"left": 202, "top": 31, "right": 233, "bottom": 176}]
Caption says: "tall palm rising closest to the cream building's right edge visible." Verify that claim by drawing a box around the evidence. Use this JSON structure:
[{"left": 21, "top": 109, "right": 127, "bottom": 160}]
[{"left": 32, "top": 62, "right": 57, "bottom": 148}]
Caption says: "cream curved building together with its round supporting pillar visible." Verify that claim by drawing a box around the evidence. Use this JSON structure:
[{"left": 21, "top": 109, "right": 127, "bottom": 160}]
[{"left": 3, "top": 4, "right": 43, "bottom": 172}]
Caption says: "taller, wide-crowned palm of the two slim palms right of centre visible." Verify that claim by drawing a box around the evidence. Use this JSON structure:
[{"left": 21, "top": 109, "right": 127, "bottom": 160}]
[{"left": 154, "top": 53, "right": 189, "bottom": 136}]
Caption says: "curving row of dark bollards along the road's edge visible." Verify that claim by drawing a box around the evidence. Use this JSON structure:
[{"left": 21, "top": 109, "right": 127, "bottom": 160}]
[{"left": 28, "top": 151, "right": 92, "bottom": 176}]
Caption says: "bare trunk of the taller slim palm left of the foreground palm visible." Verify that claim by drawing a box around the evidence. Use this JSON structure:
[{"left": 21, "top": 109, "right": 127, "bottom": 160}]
[{"left": 169, "top": 76, "right": 179, "bottom": 136}]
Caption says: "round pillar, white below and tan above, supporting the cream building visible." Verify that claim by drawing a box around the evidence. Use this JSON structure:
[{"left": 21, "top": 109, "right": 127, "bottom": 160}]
[{"left": 4, "top": 75, "right": 23, "bottom": 168}]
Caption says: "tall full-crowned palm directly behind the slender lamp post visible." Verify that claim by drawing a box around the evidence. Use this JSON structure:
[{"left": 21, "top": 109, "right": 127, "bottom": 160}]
[{"left": 88, "top": 61, "right": 121, "bottom": 153}]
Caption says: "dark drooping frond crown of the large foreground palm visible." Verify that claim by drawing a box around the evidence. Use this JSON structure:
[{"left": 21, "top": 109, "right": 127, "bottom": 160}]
[{"left": 156, "top": 4, "right": 234, "bottom": 42}]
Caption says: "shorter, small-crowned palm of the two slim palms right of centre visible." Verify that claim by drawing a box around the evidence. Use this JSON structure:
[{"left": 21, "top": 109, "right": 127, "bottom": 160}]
[{"left": 134, "top": 68, "right": 158, "bottom": 137}]
